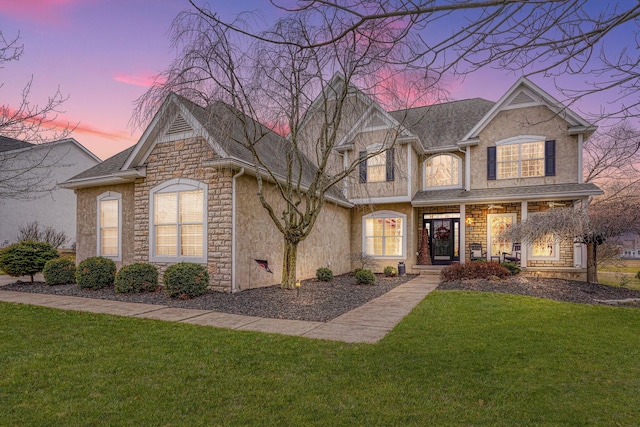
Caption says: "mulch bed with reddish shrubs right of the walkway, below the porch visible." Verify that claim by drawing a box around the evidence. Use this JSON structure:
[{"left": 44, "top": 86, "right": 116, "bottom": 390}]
[{"left": 438, "top": 276, "right": 640, "bottom": 307}]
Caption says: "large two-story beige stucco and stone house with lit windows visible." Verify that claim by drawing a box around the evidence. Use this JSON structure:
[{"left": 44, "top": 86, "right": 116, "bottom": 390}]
[{"left": 65, "top": 75, "right": 602, "bottom": 292}]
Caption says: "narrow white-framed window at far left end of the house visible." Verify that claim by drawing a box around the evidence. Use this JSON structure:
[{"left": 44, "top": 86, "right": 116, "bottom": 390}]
[{"left": 96, "top": 191, "right": 122, "bottom": 261}]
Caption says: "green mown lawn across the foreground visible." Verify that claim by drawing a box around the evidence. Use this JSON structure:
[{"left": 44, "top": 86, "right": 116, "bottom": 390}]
[{"left": 0, "top": 291, "right": 640, "bottom": 426}]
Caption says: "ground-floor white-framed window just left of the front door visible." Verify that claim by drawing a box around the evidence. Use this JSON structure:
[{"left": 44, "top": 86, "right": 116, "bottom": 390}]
[{"left": 362, "top": 211, "right": 407, "bottom": 258}]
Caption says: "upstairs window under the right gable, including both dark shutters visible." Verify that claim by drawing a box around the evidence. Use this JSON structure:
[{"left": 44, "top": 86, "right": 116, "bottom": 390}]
[{"left": 487, "top": 135, "right": 556, "bottom": 180}]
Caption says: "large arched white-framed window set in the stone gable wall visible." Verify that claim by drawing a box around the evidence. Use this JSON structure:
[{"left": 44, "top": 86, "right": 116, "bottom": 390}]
[{"left": 149, "top": 178, "right": 207, "bottom": 263}]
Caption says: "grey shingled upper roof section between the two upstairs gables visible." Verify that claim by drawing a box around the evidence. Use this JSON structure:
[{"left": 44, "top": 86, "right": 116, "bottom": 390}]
[{"left": 390, "top": 98, "right": 495, "bottom": 151}]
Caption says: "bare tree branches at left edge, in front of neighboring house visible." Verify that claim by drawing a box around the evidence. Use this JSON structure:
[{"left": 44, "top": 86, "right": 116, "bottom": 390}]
[{"left": 0, "top": 31, "right": 72, "bottom": 202}]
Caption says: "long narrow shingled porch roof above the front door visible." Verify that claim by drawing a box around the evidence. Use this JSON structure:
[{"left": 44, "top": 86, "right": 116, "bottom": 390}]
[{"left": 411, "top": 183, "right": 603, "bottom": 206}]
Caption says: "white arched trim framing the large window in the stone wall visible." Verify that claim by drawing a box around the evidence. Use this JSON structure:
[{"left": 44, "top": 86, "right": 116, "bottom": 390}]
[{"left": 149, "top": 178, "right": 209, "bottom": 264}]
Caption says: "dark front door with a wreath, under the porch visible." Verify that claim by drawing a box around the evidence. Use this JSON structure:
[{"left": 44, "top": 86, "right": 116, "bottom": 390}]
[{"left": 423, "top": 218, "right": 460, "bottom": 265}]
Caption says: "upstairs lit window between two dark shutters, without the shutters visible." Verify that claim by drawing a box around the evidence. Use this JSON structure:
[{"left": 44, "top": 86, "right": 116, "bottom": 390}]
[{"left": 497, "top": 140, "right": 545, "bottom": 179}]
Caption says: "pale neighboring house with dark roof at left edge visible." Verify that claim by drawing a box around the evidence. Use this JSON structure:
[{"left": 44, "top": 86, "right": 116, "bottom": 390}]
[{"left": 0, "top": 136, "right": 100, "bottom": 247}]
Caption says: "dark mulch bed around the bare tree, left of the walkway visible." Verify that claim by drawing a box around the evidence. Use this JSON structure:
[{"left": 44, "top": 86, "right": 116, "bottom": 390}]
[{"left": 0, "top": 274, "right": 416, "bottom": 322}]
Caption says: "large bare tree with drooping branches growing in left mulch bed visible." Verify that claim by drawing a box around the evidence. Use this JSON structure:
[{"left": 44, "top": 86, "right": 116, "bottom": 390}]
[{"left": 135, "top": 3, "right": 438, "bottom": 288}]
